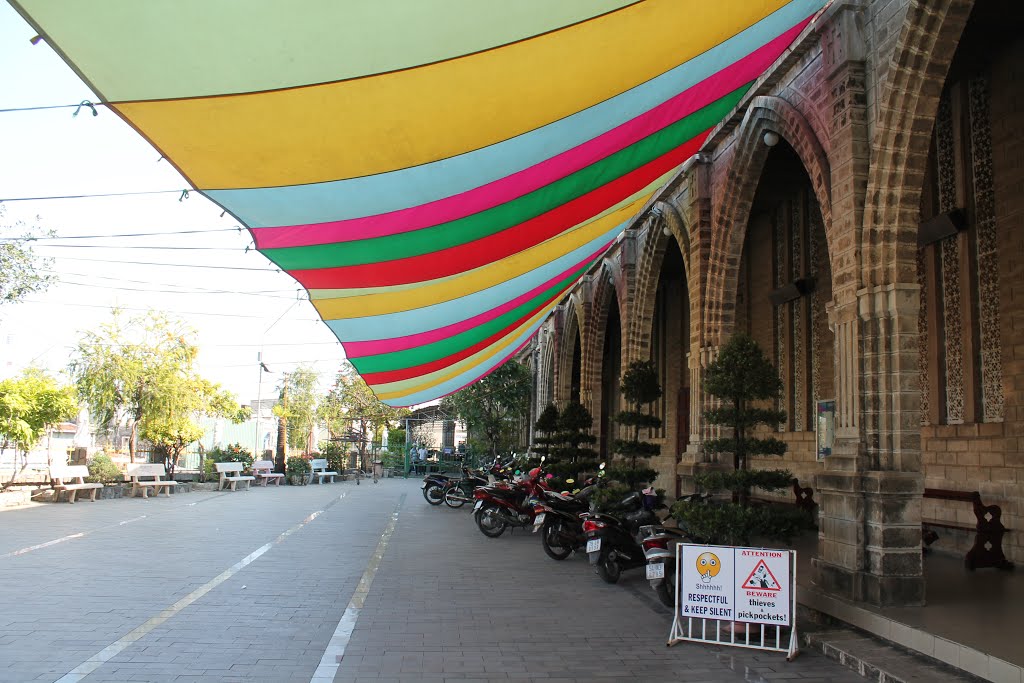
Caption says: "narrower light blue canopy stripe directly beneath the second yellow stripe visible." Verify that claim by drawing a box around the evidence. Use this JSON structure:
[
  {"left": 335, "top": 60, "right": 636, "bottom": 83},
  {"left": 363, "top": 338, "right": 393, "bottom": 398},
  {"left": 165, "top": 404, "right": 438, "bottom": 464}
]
[{"left": 325, "top": 221, "right": 628, "bottom": 341}]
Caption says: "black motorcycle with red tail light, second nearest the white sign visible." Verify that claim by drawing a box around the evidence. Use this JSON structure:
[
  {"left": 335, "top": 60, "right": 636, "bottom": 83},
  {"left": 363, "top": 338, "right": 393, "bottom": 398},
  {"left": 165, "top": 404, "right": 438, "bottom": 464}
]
[{"left": 583, "top": 493, "right": 656, "bottom": 584}]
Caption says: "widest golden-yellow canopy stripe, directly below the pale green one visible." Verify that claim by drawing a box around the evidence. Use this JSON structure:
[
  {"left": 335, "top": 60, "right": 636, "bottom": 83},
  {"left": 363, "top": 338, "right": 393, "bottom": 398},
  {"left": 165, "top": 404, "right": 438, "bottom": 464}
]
[{"left": 116, "top": 0, "right": 785, "bottom": 189}]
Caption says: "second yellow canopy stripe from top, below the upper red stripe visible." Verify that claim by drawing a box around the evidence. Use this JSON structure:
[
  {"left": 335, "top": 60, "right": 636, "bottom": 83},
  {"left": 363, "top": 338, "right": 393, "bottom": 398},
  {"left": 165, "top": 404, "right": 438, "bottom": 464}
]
[{"left": 312, "top": 188, "right": 664, "bottom": 321}]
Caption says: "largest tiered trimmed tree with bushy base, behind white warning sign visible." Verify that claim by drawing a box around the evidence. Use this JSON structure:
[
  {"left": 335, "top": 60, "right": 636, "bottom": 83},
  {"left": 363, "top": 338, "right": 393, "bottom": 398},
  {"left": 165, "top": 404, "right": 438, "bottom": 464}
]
[{"left": 672, "top": 334, "right": 807, "bottom": 545}]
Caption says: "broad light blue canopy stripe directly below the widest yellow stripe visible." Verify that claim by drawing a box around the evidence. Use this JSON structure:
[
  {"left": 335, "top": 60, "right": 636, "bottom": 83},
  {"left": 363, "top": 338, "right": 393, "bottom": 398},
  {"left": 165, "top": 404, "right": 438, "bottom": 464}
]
[{"left": 204, "top": 0, "right": 820, "bottom": 227}]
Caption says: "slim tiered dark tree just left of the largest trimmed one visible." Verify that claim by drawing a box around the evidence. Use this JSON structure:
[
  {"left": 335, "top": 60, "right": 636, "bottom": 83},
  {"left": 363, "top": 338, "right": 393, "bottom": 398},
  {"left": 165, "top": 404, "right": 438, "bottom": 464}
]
[{"left": 608, "top": 360, "right": 662, "bottom": 492}]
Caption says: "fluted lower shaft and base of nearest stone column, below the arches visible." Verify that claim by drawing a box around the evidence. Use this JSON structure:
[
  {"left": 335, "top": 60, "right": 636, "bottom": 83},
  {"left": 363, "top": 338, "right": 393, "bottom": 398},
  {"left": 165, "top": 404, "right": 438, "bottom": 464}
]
[{"left": 814, "top": 284, "right": 925, "bottom": 605}]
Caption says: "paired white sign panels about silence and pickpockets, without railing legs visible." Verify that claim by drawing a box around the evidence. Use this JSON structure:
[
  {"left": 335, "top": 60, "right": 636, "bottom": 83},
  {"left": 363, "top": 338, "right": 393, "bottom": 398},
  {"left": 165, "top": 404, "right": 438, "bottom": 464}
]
[{"left": 679, "top": 544, "right": 793, "bottom": 626}]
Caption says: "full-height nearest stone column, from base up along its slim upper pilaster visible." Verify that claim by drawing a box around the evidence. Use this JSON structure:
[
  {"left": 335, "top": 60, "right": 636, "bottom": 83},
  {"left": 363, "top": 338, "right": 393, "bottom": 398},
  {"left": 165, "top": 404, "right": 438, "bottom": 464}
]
[{"left": 813, "top": 3, "right": 925, "bottom": 605}]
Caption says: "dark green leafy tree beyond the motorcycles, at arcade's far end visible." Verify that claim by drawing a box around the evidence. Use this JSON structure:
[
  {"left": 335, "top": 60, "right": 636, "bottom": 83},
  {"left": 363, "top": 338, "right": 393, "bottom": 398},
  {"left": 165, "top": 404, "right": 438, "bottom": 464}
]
[{"left": 441, "top": 361, "right": 531, "bottom": 457}]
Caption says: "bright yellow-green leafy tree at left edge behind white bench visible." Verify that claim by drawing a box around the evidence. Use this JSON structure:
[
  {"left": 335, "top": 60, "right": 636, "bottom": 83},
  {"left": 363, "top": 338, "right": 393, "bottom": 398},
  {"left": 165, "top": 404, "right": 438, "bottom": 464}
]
[{"left": 0, "top": 368, "right": 78, "bottom": 453}]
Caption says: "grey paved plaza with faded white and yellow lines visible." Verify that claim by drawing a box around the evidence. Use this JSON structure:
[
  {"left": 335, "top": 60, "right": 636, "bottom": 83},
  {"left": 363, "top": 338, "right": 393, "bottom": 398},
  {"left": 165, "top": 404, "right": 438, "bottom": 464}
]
[{"left": 0, "top": 479, "right": 862, "bottom": 683}]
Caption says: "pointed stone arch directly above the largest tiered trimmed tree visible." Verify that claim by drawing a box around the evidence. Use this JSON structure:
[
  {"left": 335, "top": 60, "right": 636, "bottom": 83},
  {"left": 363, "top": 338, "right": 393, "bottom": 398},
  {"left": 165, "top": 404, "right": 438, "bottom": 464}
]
[{"left": 703, "top": 96, "right": 837, "bottom": 341}]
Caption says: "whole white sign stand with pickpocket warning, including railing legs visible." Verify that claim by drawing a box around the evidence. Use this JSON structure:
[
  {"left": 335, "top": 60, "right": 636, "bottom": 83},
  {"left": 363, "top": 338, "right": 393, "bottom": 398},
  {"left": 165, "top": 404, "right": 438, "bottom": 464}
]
[{"left": 666, "top": 543, "right": 800, "bottom": 661}]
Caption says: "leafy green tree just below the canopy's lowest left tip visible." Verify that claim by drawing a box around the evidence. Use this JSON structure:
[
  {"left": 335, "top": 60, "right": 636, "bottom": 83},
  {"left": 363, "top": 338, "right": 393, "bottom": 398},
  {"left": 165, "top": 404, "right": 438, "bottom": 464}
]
[{"left": 317, "top": 362, "right": 410, "bottom": 465}]
